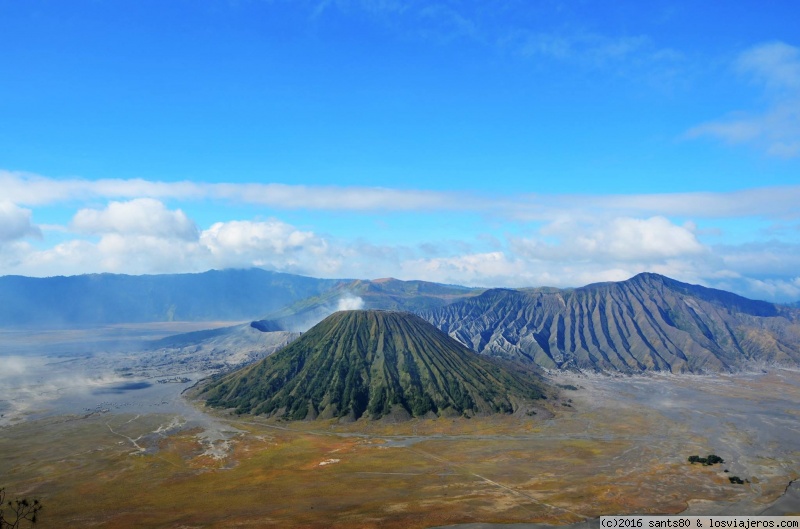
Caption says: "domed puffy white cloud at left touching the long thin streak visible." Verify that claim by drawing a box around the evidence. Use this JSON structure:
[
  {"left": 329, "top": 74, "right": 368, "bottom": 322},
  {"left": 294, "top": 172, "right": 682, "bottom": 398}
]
[{"left": 72, "top": 198, "right": 198, "bottom": 240}]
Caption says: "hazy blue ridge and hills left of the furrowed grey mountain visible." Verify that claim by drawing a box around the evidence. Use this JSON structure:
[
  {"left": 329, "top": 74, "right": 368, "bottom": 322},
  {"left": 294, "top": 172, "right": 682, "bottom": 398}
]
[{"left": 0, "top": 268, "right": 482, "bottom": 331}]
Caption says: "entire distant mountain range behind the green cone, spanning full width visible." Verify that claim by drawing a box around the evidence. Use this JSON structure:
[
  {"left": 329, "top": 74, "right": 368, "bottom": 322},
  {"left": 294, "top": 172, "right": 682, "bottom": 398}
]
[{"left": 0, "top": 269, "right": 800, "bottom": 373}]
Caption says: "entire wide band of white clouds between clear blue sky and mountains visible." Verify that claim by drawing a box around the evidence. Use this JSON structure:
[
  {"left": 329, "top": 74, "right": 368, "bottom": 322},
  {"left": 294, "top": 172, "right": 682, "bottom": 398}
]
[{"left": 0, "top": 172, "right": 800, "bottom": 300}]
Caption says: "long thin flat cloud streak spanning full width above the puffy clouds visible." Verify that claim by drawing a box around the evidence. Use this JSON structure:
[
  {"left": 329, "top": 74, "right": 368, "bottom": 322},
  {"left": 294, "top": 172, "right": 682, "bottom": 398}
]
[{"left": 0, "top": 170, "right": 800, "bottom": 221}]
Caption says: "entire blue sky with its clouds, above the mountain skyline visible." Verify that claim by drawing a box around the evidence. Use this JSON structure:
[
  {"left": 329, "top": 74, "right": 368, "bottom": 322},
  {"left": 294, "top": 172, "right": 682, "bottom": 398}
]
[{"left": 0, "top": 0, "right": 800, "bottom": 301}]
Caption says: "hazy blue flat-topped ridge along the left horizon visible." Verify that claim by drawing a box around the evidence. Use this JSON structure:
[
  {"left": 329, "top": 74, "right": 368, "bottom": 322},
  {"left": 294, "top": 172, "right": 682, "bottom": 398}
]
[{"left": 0, "top": 268, "right": 340, "bottom": 326}]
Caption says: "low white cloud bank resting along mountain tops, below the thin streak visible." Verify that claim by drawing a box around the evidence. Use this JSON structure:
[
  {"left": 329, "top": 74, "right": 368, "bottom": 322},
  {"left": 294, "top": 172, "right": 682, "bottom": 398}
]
[{"left": 0, "top": 204, "right": 800, "bottom": 300}]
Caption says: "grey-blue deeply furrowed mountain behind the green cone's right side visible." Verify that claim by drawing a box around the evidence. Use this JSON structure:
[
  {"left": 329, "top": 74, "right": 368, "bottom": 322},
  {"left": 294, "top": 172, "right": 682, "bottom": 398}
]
[{"left": 421, "top": 274, "right": 800, "bottom": 373}]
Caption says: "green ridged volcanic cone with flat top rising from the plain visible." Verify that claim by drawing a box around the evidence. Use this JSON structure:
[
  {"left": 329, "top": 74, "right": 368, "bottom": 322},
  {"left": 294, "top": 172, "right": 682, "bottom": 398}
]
[{"left": 201, "top": 310, "right": 543, "bottom": 419}]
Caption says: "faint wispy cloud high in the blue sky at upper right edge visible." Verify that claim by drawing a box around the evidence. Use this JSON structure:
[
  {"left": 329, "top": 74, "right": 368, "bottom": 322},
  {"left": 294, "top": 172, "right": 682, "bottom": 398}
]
[{"left": 686, "top": 42, "right": 800, "bottom": 158}]
